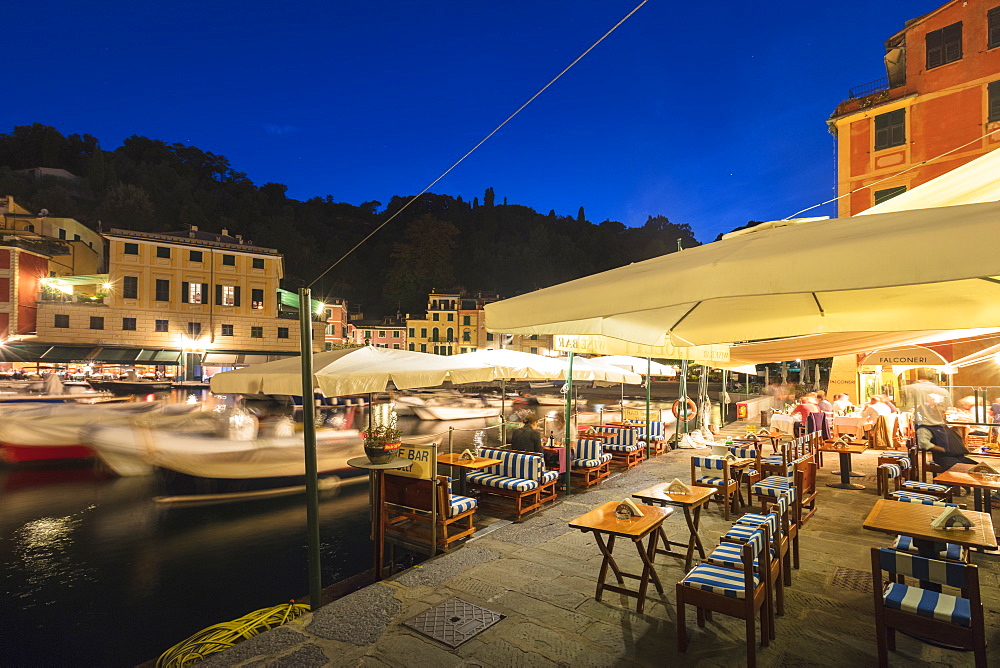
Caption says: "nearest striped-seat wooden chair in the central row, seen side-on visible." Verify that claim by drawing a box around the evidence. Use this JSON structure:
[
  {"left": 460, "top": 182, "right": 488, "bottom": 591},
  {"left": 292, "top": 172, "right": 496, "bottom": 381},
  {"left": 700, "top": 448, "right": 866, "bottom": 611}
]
[{"left": 677, "top": 525, "right": 771, "bottom": 668}]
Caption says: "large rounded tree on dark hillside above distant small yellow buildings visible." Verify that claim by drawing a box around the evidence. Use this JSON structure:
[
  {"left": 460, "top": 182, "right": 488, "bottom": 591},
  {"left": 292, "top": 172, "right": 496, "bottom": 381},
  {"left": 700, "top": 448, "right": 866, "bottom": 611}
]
[{"left": 382, "top": 215, "right": 459, "bottom": 311}]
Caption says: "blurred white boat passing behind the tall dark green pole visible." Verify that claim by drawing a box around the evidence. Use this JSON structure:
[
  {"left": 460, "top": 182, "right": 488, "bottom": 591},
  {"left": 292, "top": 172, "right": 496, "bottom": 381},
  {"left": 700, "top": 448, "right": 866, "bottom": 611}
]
[{"left": 86, "top": 420, "right": 364, "bottom": 479}]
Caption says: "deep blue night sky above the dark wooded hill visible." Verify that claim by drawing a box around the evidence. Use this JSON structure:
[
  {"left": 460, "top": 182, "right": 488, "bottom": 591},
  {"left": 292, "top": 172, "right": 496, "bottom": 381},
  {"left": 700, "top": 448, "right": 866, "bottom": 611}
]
[{"left": 0, "top": 0, "right": 943, "bottom": 241}]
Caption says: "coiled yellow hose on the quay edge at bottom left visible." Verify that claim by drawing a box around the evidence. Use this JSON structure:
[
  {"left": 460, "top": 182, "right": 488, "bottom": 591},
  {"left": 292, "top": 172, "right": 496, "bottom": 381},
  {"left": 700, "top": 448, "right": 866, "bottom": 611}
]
[{"left": 156, "top": 603, "right": 309, "bottom": 668}]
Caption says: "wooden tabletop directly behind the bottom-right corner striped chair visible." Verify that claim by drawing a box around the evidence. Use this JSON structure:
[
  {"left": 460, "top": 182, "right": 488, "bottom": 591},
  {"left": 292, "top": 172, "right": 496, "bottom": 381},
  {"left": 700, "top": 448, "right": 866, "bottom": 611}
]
[{"left": 862, "top": 499, "right": 997, "bottom": 559}]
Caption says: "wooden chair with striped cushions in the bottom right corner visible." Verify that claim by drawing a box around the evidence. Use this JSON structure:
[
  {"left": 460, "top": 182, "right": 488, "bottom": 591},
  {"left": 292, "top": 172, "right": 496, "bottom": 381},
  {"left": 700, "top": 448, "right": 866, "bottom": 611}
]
[{"left": 871, "top": 547, "right": 988, "bottom": 668}]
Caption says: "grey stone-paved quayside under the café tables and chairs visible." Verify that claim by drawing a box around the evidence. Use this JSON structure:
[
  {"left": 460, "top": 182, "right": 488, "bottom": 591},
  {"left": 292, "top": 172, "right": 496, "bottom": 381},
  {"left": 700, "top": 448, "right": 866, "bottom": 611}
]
[{"left": 203, "top": 425, "right": 1000, "bottom": 668}]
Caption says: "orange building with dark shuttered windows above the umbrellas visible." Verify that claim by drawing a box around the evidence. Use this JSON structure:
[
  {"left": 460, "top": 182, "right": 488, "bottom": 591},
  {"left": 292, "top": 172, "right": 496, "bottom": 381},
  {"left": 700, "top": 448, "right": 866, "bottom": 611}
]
[{"left": 827, "top": 0, "right": 1000, "bottom": 216}]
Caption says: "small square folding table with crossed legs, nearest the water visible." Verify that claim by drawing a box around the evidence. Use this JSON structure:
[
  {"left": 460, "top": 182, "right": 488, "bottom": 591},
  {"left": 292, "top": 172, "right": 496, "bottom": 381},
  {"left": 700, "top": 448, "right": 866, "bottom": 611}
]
[{"left": 569, "top": 501, "right": 672, "bottom": 613}]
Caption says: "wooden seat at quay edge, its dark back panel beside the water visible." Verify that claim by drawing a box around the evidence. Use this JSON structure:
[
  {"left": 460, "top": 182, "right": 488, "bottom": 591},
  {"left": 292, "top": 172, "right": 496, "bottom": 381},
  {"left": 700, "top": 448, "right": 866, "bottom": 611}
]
[{"left": 382, "top": 475, "right": 478, "bottom": 551}]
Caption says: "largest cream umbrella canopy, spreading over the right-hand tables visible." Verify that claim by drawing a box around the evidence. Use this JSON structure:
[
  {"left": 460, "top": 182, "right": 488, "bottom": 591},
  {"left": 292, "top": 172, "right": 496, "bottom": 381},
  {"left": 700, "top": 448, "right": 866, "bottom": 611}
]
[{"left": 486, "top": 202, "right": 1000, "bottom": 345}]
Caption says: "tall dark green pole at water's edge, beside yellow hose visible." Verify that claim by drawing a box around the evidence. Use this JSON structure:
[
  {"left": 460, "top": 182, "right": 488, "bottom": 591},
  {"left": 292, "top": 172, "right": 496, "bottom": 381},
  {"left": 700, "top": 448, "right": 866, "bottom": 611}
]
[{"left": 299, "top": 288, "right": 320, "bottom": 611}]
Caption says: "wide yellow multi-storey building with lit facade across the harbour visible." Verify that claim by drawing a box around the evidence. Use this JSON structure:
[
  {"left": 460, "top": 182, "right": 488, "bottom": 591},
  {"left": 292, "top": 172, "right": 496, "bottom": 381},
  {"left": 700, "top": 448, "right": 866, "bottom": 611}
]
[{"left": 29, "top": 228, "right": 324, "bottom": 377}]
